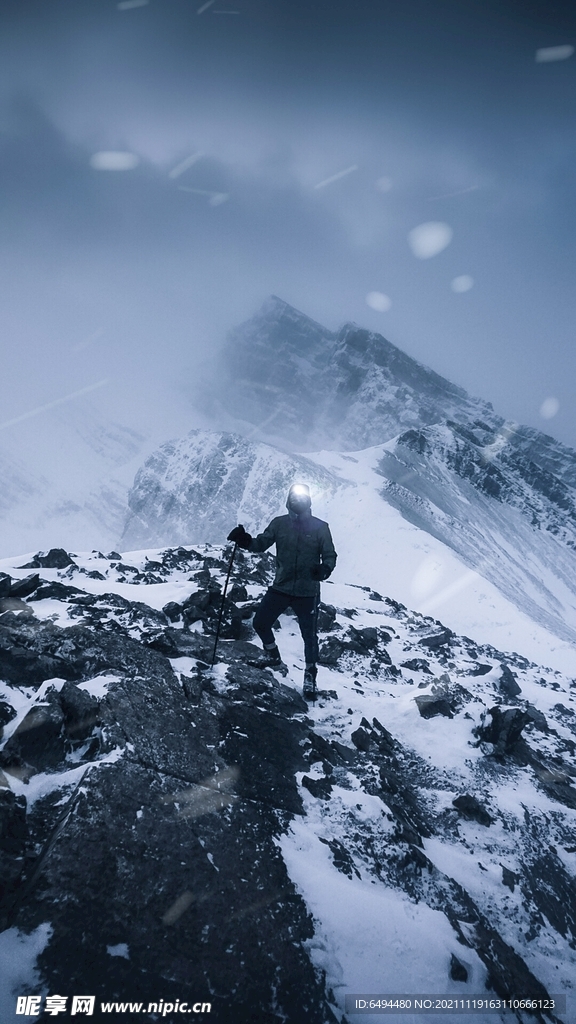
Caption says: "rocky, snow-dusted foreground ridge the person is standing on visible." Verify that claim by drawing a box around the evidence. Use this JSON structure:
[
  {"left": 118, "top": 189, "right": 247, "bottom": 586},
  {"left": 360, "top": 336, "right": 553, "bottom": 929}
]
[{"left": 0, "top": 545, "right": 576, "bottom": 1024}]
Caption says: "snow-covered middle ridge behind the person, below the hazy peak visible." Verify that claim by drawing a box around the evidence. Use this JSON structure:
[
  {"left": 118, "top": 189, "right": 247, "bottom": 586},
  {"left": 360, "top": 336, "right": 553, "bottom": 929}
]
[{"left": 123, "top": 431, "right": 576, "bottom": 671}]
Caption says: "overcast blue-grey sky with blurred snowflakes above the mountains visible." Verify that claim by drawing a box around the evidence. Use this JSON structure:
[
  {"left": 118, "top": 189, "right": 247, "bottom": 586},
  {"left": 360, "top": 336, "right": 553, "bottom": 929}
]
[{"left": 0, "top": 0, "right": 576, "bottom": 446}]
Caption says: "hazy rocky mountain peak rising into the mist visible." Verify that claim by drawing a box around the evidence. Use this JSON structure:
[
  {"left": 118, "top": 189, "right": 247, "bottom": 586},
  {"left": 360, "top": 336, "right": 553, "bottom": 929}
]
[{"left": 198, "top": 296, "right": 503, "bottom": 452}]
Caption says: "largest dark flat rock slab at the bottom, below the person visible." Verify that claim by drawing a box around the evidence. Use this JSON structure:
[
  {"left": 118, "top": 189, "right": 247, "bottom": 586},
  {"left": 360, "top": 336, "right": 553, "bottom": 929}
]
[{"left": 15, "top": 761, "right": 330, "bottom": 1024}]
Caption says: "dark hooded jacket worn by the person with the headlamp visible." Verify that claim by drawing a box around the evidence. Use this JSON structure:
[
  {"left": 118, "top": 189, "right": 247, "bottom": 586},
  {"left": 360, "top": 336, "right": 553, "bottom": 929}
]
[{"left": 248, "top": 511, "right": 336, "bottom": 597}]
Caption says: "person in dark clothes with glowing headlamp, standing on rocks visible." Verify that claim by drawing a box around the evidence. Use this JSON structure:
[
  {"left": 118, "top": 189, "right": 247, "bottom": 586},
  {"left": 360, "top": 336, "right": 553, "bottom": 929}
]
[{"left": 228, "top": 483, "right": 336, "bottom": 698}]
